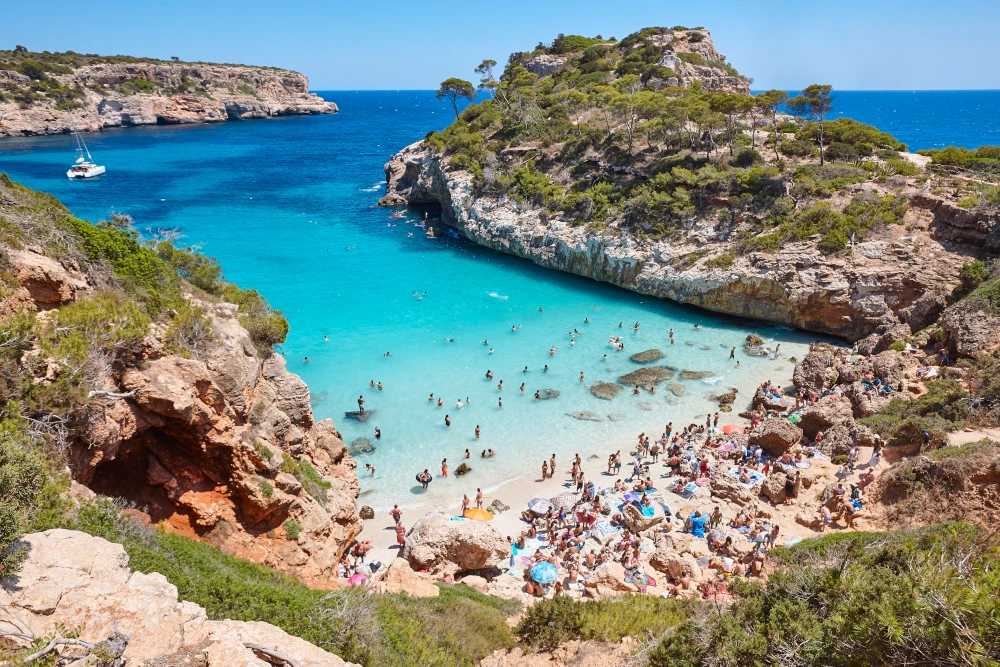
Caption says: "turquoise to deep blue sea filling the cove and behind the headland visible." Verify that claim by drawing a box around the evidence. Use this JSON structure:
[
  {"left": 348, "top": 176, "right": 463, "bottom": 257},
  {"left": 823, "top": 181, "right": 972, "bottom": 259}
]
[{"left": 0, "top": 91, "right": 1000, "bottom": 507}]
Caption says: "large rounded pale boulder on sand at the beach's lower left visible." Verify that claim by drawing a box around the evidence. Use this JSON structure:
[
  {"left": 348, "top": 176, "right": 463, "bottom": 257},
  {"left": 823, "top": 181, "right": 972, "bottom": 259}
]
[{"left": 409, "top": 512, "right": 510, "bottom": 574}]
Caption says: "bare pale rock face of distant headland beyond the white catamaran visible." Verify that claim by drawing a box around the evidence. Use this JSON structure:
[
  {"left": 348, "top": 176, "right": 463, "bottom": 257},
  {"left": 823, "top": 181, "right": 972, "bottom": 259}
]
[{"left": 0, "top": 63, "right": 337, "bottom": 137}]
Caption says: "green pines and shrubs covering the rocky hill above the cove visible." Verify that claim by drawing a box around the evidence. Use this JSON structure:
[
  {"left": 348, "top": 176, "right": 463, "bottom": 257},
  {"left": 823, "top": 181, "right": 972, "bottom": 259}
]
[{"left": 425, "top": 28, "right": 921, "bottom": 258}]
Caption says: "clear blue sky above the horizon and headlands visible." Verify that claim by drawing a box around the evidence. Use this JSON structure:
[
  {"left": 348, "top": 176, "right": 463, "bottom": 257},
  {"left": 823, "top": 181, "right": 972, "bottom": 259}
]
[{"left": 7, "top": 0, "right": 1000, "bottom": 90}]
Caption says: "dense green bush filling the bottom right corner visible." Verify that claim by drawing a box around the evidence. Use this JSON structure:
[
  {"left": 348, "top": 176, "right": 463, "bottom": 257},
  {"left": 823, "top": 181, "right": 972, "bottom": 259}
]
[{"left": 649, "top": 524, "right": 1000, "bottom": 667}]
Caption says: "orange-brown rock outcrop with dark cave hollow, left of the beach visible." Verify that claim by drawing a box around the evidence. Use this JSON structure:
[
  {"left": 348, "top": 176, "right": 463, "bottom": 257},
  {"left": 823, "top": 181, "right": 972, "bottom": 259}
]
[{"left": 5, "top": 250, "right": 361, "bottom": 586}]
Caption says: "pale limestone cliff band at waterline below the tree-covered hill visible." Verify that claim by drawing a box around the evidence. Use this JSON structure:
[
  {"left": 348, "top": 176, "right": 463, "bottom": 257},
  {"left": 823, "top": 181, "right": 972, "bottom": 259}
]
[{"left": 380, "top": 143, "right": 984, "bottom": 339}]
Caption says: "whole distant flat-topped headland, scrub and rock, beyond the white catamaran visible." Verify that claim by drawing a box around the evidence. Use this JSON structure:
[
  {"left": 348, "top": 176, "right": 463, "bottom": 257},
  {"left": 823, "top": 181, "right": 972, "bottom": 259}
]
[{"left": 0, "top": 50, "right": 337, "bottom": 137}]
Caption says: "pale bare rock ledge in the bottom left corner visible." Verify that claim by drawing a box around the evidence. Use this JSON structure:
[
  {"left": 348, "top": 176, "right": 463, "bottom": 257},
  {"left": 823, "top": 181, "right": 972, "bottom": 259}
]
[{"left": 0, "top": 530, "right": 356, "bottom": 667}]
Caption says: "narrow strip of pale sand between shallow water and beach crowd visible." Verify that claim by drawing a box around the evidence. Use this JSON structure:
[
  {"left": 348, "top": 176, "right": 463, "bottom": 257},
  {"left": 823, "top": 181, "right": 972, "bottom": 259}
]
[{"left": 357, "top": 344, "right": 808, "bottom": 562}]
